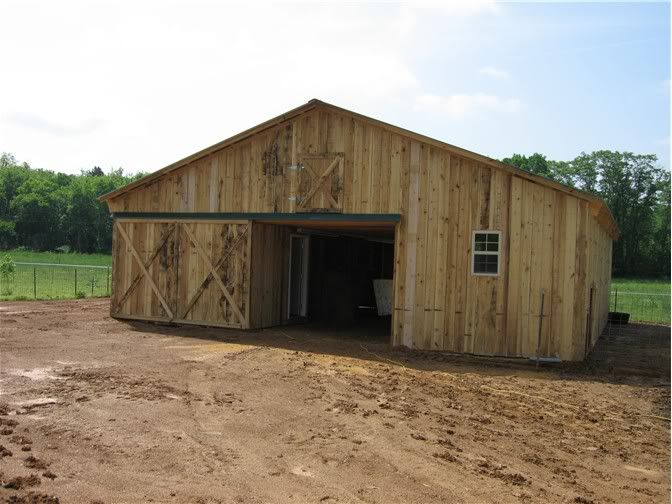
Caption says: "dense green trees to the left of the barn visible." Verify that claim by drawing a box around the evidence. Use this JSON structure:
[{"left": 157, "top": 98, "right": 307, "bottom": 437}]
[{"left": 0, "top": 153, "right": 137, "bottom": 253}]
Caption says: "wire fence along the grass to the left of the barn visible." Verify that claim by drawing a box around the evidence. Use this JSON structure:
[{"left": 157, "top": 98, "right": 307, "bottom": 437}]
[{"left": 0, "top": 262, "right": 111, "bottom": 300}]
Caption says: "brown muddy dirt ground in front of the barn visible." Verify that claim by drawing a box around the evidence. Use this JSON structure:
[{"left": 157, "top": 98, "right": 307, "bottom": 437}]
[{"left": 0, "top": 300, "right": 670, "bottom": 504}]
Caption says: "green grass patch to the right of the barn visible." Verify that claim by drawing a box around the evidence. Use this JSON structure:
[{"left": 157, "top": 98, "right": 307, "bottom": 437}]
[{"left": 609, "top": 278, "right": 670, "bottom": 325}]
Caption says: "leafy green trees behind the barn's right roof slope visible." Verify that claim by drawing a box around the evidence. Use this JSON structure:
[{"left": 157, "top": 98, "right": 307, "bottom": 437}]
[{"left": 502, "top": 150, "right": 670, "bottom": 277}]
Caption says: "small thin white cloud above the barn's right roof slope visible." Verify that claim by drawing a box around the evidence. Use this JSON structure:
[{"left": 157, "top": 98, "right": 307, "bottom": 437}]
[{"left": 415, "top": 93, "right": 522, "bottom": 119}]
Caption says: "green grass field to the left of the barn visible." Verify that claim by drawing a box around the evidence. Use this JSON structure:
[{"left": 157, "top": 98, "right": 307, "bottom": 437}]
[{"left": 0, "top": 250, "right": 112, "bottom": 301}]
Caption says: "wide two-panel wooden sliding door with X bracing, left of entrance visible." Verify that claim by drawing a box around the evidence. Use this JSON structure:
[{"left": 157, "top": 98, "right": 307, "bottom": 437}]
[{"left": 111, "top": 221, "right": 251, "bottom": 328}]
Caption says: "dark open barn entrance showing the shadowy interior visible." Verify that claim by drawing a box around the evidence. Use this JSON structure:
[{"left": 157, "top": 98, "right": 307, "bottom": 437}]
[{"left": 288, "top": 229, "right": 394, "bottom": 341}]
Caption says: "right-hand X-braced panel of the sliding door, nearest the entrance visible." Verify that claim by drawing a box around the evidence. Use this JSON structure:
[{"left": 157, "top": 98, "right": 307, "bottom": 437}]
[{"left": 175, "top": 222, "right": 251, "bottom": 328}]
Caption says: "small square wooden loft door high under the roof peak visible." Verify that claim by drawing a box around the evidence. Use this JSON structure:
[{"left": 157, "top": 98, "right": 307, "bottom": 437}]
[{"left": 296, "top": 153, "right": 343, "bottom": 212}]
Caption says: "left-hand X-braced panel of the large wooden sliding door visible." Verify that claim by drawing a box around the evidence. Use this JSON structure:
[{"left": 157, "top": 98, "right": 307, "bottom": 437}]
[{"left": 110, "top": 221, "right": 177, "bottom": 321}]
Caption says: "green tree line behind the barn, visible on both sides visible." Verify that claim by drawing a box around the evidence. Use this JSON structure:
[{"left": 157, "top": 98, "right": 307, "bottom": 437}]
[{"left": 0, "top": 150, "right": 670, "bottom": 276}]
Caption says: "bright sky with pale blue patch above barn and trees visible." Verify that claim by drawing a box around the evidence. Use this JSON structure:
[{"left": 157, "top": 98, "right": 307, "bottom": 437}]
[{"left": 0, "top": 0, "right": 670, "bottom": 173}]
